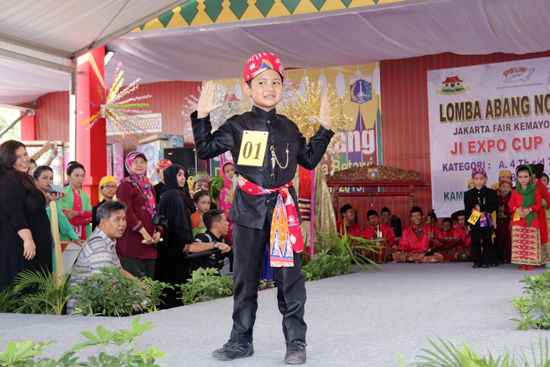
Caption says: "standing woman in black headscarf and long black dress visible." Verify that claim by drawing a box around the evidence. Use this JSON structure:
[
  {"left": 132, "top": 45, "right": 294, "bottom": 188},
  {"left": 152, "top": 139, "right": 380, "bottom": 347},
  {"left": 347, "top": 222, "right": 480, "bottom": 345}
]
[{"left": 155, "top": 164, "right": 195, "bottom": 308}]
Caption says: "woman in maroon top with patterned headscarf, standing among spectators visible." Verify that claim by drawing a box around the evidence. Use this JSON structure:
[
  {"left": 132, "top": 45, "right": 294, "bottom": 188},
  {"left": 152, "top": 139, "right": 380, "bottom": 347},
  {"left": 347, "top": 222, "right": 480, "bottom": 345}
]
[{"left": 116, "top": 152, "right": 162, "bottom": 278}]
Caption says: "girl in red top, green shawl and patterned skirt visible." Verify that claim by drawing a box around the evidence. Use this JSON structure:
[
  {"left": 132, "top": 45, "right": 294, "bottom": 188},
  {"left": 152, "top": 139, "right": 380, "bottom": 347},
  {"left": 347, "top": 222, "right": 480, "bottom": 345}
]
[{"left": 508, "top": 165, "right": 542, "bottom": 270}]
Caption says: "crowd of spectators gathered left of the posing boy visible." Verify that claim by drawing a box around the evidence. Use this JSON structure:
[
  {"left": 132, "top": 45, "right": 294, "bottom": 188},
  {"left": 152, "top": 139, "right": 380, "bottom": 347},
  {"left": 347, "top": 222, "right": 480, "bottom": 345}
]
[{"left": 0, "top": 140, "right": 233, "bottom": 313}]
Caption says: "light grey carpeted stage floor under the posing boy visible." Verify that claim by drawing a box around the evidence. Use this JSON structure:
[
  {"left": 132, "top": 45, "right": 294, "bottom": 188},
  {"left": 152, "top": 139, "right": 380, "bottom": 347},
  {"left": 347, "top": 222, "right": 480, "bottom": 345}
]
[{"left": 0, "top": 263, "right": 548, "bottom": 367}]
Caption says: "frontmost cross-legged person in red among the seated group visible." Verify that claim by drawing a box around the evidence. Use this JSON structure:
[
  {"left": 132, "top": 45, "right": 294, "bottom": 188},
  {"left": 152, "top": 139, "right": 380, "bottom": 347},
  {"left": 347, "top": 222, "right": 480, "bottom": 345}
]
[{"left": 393, "top": 206, "right": 444, "bottom": 263}]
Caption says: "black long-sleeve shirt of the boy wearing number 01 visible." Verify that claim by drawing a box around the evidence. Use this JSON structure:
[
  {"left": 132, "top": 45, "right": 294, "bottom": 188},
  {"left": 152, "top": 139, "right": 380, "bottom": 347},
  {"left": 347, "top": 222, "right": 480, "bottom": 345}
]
[{"left": 191, "top": 106, "right": 334, "bottom": 229}]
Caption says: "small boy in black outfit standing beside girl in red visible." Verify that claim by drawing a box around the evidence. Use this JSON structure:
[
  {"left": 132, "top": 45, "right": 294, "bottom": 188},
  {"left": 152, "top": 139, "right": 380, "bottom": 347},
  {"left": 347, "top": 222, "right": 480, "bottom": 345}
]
[{"left": 464, "top": 167, "right": 498, "bottom": 268}]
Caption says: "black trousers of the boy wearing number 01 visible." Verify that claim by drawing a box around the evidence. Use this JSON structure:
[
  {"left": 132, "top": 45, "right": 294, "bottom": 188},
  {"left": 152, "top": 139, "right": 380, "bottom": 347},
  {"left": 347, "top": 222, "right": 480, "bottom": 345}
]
[{"left": 229, "top": 221, "right": 307, "bottom": 344}]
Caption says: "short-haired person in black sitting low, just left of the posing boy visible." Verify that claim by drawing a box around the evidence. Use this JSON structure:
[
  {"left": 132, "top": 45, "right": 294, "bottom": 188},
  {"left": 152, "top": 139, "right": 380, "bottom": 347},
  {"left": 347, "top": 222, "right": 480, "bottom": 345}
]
[{"left": 189, "top": 209, "right": 232, "bottom": 271}]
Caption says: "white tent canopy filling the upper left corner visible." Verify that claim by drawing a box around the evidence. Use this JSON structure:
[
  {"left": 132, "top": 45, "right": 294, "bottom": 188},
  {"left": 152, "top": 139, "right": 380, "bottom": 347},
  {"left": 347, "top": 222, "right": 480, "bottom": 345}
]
[{"left": 0, "top": 0, "right": 190, "bottom": 104}]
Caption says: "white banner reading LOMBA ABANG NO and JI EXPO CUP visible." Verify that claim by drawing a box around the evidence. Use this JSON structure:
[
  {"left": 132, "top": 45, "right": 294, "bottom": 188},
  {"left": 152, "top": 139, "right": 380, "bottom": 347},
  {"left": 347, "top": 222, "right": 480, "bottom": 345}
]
[{"left": 428, "top": 58, "right": 550, "bottom": 216}]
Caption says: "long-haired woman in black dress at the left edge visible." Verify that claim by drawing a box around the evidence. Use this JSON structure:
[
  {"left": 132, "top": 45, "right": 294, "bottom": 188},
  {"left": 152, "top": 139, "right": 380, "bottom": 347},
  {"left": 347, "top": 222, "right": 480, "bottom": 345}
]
[{"left": 0, "top": 140, "right": 57, "bottom": 288}]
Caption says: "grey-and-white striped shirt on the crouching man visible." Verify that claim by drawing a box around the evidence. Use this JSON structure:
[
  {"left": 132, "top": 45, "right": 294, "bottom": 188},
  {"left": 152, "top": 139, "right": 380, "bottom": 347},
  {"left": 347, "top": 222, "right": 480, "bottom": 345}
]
[{"left": 67, "top": 227, "right": 122, "bottom": 315}]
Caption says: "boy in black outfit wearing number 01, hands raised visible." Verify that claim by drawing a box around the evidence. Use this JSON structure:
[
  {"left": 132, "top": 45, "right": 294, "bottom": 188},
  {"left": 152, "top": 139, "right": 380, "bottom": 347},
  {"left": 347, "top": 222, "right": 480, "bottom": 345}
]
[{"left": 191, "top": 52, "right": 334, "bottom": 364}]
